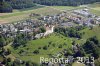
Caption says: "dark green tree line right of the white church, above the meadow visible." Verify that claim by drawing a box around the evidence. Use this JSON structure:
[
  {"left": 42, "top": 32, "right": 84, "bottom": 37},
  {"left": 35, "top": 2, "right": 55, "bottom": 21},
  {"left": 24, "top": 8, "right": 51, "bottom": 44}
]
[{"left": 54, "top": 26, "right": 85, "bottom": 39}]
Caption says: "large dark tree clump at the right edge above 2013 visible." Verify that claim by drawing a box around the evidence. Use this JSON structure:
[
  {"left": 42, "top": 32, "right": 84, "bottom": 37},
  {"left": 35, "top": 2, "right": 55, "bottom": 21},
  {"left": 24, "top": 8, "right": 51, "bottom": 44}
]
[{"left": 83, "top": 37, "right": 100, "bottom": 59}]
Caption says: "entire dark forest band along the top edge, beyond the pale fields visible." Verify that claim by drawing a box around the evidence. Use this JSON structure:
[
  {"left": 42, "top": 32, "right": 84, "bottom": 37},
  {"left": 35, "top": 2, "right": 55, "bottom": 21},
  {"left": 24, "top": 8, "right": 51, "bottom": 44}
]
[{"left": 0, "top": 0, "right": 100, "bottom": 12}]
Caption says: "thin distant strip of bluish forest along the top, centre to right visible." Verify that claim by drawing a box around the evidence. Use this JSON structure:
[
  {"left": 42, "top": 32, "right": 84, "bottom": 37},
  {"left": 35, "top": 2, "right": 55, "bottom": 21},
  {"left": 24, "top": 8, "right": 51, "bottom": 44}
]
[{"left": 33, "top": 0, "right": 100, "bottom": 6}]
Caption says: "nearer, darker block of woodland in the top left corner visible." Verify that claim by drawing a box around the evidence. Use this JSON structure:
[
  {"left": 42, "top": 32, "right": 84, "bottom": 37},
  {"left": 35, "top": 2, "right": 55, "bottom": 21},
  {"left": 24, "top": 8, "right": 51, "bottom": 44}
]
[{"left": 0, "top": 0, "right": 35, "bottom": 12}]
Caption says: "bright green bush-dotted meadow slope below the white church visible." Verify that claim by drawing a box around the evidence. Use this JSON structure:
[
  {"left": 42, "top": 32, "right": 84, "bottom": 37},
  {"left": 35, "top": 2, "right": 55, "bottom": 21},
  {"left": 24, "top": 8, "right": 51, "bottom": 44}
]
[{"left": 9, "top": 34, "right": 72, "bottom": 62}]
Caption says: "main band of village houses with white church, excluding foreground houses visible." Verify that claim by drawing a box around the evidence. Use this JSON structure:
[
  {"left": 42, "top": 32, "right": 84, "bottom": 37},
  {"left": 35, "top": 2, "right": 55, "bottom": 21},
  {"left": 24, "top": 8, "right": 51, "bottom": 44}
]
[{"left": 0, "top": 9, "right": 100, "bottom": 39}]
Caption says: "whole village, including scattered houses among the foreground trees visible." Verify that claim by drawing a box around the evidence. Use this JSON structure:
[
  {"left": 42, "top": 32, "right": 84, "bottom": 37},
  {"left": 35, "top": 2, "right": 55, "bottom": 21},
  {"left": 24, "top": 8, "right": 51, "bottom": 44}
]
[{"left": 0, "top": 8, "right": 100, "bottom": 66}]
